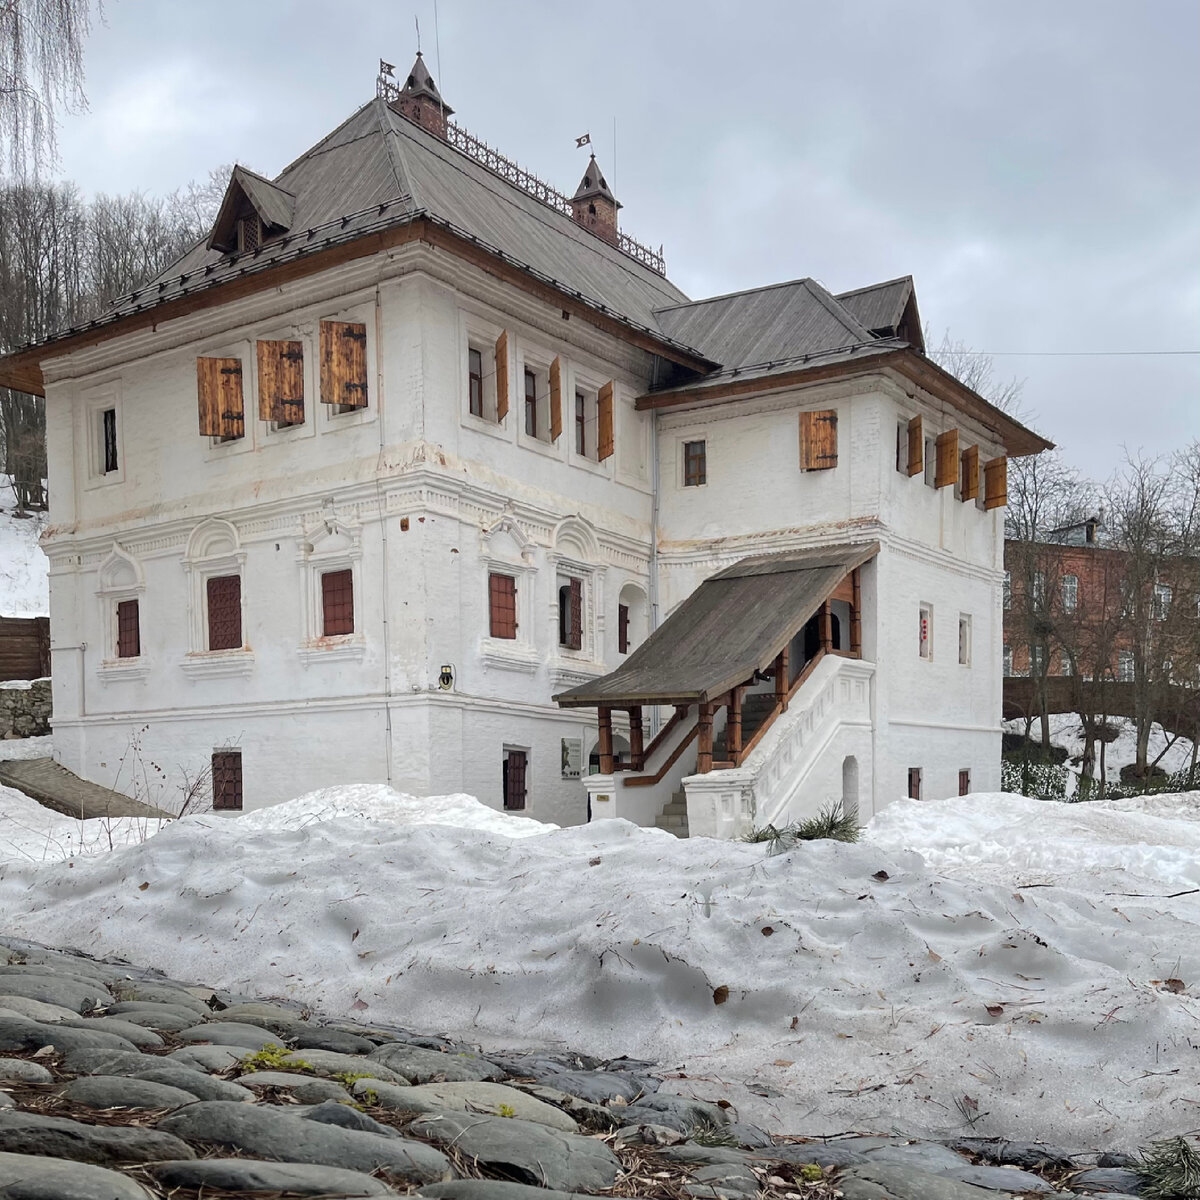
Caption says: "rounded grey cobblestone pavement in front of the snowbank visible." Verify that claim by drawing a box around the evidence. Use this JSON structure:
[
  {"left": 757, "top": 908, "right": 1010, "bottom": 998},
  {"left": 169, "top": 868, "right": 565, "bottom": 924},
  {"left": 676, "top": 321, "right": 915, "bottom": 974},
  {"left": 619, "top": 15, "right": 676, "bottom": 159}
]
[{"left": 0, "top": 936, "right": 1142, "bottom": 1200}]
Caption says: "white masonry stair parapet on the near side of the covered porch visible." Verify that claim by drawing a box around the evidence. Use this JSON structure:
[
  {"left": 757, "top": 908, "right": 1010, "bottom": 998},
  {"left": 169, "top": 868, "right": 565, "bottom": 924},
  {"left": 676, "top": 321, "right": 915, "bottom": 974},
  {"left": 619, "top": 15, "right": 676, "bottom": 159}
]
[{"left": 683, "top": 654, "right": 875, "bottom": 839}]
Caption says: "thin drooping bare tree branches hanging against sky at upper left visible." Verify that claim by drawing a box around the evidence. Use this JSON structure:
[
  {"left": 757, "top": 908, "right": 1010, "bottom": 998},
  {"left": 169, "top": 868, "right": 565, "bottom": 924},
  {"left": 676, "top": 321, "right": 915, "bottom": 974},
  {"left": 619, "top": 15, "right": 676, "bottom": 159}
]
[{"left": 0, "top": 0, "right": 100, "bottom": 178}]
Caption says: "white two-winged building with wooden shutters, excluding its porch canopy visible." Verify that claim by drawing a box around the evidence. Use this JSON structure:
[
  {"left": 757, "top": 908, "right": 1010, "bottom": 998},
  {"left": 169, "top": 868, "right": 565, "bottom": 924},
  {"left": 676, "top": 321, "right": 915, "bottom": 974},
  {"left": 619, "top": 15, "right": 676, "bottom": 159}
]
[{"left": 0, "top": 59, "right": 1046, "bottom": 833}]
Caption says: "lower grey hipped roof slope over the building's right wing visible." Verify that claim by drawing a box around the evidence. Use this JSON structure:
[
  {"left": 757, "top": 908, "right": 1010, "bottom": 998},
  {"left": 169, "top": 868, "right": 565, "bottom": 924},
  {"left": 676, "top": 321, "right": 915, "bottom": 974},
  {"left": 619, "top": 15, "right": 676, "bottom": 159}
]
[{"left": 655, "top": 280, "right": 872, "bottom": 368}]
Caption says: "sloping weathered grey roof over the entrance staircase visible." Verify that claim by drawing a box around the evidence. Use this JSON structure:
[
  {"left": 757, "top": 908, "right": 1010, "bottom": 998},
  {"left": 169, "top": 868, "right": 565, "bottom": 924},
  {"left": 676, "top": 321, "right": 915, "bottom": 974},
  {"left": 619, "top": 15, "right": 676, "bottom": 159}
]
[{"left": 554, "top": 541, "right": 880, "bottom": 708}]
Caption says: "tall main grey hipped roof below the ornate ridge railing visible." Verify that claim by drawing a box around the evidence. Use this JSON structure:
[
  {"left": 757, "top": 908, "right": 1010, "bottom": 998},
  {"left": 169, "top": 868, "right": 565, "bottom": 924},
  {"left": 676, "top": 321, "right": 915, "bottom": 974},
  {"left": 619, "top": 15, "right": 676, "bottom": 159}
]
[{"left": 16, "top": 98, "right": 702, "bottom": 358}]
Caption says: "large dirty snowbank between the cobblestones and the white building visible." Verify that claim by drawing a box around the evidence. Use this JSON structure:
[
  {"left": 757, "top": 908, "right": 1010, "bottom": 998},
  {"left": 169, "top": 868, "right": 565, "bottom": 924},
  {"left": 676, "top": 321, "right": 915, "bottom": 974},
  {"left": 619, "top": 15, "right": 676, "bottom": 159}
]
[{"left": 0, "top": 787, "right": 1200, "bottom": 1148}]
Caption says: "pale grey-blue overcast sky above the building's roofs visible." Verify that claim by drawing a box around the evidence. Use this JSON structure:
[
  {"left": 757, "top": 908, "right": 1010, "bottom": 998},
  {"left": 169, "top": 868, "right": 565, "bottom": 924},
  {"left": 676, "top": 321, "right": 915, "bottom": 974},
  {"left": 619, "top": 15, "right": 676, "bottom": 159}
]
[{"left": 51, "top": 0, "right": 1200, "bottom": 478}]
